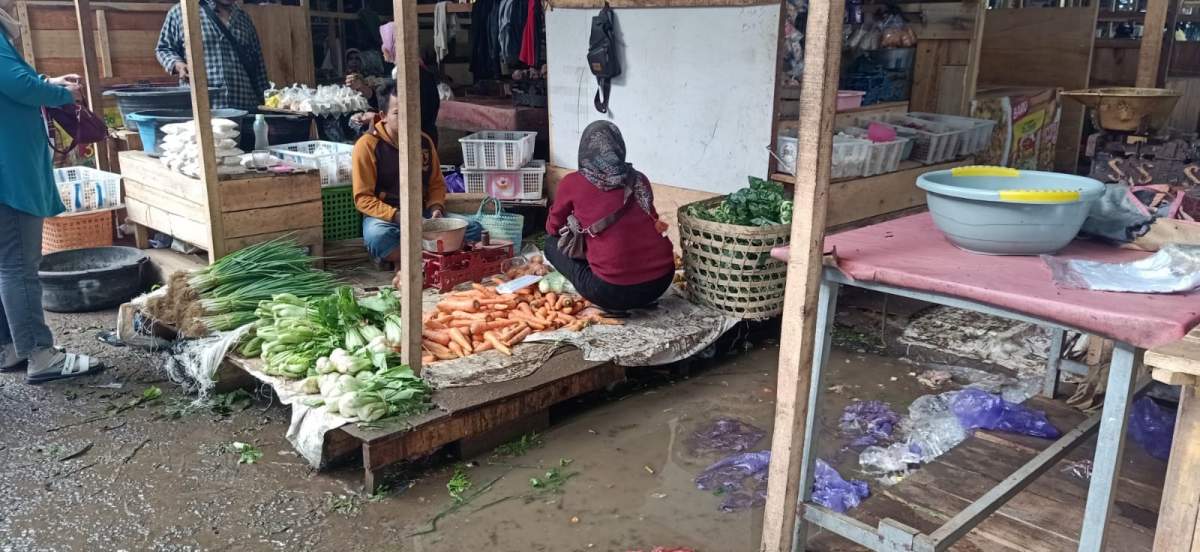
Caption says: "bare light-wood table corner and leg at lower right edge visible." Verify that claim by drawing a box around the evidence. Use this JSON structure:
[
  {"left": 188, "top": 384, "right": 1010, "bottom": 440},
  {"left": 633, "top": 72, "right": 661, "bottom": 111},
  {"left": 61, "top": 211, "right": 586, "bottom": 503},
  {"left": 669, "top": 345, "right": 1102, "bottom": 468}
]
[{"left": 1146, "top": 329, "right": 1200, "bottom": 552}]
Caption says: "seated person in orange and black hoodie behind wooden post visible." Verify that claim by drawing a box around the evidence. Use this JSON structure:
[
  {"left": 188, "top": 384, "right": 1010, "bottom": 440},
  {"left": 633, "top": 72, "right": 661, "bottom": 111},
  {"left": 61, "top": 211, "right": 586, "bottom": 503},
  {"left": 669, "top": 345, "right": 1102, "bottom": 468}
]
[{"left": 353, "top": 83, "right": 481, "bottom": 264}]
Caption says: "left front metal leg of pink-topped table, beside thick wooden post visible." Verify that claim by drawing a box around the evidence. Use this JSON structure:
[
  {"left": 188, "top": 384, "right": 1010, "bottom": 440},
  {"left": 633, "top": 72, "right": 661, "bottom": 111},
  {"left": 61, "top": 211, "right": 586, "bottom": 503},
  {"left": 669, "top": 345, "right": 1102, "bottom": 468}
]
[{"left": 784, "top": 278, "right": 841, "bottom": 552}]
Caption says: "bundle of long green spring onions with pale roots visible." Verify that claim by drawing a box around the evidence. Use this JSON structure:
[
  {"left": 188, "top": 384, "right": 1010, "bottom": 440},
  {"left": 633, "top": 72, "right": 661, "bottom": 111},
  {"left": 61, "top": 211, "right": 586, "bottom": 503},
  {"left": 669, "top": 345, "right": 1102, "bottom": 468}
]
[{"left": 187, "top": 238, "right": 336, "bottom": 331}]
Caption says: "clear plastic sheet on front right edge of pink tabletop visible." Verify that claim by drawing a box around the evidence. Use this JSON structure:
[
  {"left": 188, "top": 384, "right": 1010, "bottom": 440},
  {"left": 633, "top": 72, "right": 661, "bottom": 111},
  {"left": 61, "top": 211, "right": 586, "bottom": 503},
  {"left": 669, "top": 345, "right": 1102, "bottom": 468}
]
[{"left": 1042, "top": 244, "right": 1200, "bottom": 293}]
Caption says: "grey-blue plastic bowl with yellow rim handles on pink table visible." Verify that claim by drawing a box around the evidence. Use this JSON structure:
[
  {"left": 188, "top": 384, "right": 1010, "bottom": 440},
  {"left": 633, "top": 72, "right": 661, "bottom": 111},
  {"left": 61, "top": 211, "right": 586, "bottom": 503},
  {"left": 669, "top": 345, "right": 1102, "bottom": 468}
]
[{"left": 917, "top": 167, "right": 1104, "bottom": 254}]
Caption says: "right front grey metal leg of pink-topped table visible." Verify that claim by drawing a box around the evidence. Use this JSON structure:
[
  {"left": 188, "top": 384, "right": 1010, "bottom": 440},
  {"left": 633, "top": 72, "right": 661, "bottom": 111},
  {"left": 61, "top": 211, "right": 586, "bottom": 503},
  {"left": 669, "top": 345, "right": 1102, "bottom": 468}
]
[{"left": 1079, "top": 343, "right": 1141, "bottom": 552}]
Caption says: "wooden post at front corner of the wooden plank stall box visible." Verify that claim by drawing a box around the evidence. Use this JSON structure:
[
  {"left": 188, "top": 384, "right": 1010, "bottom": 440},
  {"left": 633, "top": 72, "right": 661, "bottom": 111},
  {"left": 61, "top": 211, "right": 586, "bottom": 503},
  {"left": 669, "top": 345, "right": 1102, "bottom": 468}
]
[{"left": 180, "top": 0, "right": 225, "bottom": 263}]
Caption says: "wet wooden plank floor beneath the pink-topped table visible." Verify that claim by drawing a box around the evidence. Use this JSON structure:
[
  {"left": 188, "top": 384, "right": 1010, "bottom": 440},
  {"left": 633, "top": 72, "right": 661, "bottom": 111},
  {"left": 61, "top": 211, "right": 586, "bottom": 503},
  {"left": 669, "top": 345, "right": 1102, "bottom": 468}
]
[{"left": 809, "top": 398, "right": 1166, "bottom": 552}]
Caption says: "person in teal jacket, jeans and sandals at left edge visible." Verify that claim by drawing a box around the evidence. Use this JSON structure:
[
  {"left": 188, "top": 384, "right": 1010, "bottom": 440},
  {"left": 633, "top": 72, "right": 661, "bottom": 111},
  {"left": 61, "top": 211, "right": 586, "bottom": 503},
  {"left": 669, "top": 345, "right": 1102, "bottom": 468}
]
[{"left": 0, "top": 0, "right": 101, "bottom": 383}]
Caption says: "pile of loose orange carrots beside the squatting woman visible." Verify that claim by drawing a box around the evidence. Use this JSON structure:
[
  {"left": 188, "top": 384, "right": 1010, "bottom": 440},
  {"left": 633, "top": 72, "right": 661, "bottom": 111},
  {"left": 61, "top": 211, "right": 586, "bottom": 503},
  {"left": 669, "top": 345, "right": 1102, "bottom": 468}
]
[{"left": 421, "top": 280, "right": 620, "bottom": 362}]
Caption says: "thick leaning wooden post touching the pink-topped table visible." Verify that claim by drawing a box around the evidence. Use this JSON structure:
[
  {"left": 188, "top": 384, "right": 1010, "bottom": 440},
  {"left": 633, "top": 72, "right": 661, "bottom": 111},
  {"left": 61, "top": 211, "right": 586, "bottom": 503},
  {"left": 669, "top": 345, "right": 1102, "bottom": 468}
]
[{"left": 761, "top": 0, "right": 845, "bottom": 552}]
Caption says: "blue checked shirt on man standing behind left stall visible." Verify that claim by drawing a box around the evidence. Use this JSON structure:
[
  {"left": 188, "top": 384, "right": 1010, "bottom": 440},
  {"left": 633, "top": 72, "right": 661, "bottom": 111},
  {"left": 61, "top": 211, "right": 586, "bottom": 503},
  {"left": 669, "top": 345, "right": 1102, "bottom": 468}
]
[{"left": 155, "top": 0, "right": 269, "bottom": 112}]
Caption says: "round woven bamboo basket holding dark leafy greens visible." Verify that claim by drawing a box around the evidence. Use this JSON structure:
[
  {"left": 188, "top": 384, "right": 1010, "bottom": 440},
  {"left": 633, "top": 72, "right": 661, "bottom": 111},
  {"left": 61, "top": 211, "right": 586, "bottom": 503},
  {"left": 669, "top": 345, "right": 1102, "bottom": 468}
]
[{"left": 679, "top": 198, "right": 792, "bottom": 320}]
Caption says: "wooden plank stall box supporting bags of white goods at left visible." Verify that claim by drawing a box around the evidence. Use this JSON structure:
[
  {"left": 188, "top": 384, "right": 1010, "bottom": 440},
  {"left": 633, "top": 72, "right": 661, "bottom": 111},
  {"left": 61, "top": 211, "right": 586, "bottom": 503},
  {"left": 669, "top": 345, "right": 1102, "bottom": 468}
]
[{"left": 119, "top": 151, "right": 324, "bottom": 262}]
